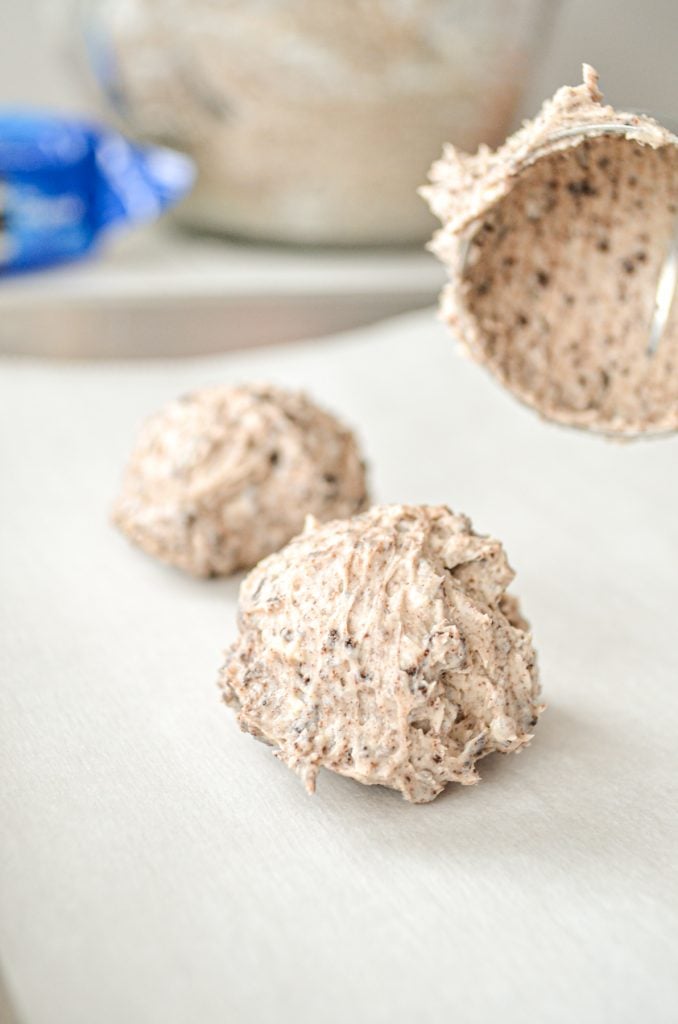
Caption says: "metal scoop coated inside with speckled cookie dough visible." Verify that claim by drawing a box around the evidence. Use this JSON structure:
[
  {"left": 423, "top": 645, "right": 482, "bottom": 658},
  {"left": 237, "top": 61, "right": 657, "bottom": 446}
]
[{"left": 422, "top": 66, "right": 678, "bottom": 436}]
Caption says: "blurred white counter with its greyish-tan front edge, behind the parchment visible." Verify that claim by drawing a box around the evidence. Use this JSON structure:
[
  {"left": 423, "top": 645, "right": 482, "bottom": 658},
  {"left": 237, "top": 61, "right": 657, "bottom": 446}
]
[{"left": 0, "top": 229, "right": 444, "bottom": 358}]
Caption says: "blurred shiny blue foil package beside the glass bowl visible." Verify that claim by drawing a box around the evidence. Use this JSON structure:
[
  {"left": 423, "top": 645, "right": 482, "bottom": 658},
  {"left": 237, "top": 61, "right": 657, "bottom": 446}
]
[{"left": 0, "top": 112, "right": 195, "bottom": 274}]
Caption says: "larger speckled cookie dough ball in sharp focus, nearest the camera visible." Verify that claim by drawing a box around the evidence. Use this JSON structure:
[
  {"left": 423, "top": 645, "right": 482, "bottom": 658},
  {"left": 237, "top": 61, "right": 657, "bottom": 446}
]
[{"left": 220, "top": 505, "right": 543, "bottom": 803}]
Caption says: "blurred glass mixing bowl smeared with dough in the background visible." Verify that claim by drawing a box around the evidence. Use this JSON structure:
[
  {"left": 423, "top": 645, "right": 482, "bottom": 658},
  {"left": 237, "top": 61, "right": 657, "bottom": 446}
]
[{"left": 78, "top": 0, "right": 554, "bottom": 245}]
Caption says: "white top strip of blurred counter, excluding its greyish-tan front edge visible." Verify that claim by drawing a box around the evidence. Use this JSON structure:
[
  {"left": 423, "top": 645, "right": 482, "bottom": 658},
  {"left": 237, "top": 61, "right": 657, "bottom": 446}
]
[{"left": 0, "top": 232, "right": 444, "bottom": 312}]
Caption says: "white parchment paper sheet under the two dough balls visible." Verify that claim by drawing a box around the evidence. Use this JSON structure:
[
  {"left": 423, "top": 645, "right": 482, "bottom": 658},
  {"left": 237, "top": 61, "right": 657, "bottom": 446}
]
[{"left": 0, "top": 311, "right": 678, "bottom": 1024}]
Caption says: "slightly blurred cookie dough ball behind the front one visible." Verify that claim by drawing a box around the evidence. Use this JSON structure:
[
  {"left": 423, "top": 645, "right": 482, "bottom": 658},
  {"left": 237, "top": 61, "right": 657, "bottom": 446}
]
[{"left": 113, "top": 385, "right": 367, "bottom": 577}]
